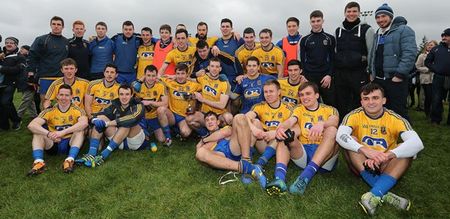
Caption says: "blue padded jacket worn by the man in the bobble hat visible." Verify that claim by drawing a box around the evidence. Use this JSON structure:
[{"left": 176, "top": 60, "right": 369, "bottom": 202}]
[{"left": 369, "top": 16, "right": 417, "bottom": 78}]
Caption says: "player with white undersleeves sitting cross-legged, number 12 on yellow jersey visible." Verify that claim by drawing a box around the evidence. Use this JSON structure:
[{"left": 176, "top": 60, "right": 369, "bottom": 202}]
[{"left": 336, "top": 83, "right": 423, "bottom": 215}]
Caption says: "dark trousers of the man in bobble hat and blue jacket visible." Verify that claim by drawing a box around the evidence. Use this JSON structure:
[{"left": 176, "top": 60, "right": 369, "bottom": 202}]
[{"left": 374, "top": 78, "right": 410, "bottom": 121}]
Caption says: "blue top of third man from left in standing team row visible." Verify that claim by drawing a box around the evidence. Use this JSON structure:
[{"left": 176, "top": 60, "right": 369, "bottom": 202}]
[{"left": 89, "top": 37, "right": 114, "bottom": 73}]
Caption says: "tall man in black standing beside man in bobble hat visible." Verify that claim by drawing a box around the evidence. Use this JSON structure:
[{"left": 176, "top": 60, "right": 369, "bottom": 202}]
[{"left": 334, "top": 2, "right": 375, "bottom": 120}]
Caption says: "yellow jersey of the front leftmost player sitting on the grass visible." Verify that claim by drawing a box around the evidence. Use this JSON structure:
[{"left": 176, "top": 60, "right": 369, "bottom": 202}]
[{"left": 38, "top": 104, "right": 86, "bottom": 138}]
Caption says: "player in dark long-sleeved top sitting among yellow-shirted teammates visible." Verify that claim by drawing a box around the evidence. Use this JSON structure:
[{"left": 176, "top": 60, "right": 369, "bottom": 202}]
[{"left": 76, "top": 84, "right": 145, "bottom": 167}]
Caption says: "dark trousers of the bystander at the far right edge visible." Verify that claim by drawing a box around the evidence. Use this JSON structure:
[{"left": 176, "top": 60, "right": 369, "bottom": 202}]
[{"left": 431, "top": 74, "right": 450, "bottom": 125}]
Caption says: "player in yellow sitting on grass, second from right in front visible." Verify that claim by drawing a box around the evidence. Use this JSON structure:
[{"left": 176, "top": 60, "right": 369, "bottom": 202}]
[{"left": 266, "top": 81, "right": 339, "bottom": 195}]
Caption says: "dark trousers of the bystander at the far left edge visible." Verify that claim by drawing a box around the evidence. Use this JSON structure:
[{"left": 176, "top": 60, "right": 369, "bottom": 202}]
[{"left": 0, "top": 85, "right": 20, "bottom": 130}]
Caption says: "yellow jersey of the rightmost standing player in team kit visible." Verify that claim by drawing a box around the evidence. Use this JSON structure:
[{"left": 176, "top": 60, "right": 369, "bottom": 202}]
[{"left": 252, "top": 45, "right": 284, "bottom": 75}]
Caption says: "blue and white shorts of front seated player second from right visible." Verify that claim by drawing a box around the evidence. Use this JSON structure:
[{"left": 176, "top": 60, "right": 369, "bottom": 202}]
[{"left": 292, "top": 144, "right": 339, "bottom": 173}]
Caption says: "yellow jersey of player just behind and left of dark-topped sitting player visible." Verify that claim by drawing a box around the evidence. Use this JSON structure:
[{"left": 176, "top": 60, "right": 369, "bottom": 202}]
[{"left": 86, "top": 79, "right": 120, "bottom": 113}]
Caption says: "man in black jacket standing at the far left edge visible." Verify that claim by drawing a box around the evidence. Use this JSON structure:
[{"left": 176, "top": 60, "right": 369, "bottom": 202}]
[{"left": 0, "top": 37, "right": 25, "bottom": 130}]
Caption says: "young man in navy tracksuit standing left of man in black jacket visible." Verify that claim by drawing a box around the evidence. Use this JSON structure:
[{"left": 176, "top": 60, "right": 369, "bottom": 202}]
[{"left": 300, "top": 10, "right": 336, "bottom": 106}]
